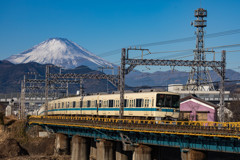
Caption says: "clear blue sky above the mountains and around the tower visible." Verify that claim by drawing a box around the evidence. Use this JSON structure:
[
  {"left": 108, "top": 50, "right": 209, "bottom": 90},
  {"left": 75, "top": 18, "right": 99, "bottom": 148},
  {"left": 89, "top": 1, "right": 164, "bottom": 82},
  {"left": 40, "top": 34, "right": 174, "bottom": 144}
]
[{"left": 0, "top": 0, "right": 240, "bottom": 72}]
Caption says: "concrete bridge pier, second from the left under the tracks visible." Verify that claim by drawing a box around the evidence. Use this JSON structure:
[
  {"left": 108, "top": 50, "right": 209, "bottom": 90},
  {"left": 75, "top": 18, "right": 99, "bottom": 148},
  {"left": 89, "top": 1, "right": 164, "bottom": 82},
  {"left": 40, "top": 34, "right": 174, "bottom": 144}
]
[{"left": 71, "top": 135, "right": 88, "bottom": 160}]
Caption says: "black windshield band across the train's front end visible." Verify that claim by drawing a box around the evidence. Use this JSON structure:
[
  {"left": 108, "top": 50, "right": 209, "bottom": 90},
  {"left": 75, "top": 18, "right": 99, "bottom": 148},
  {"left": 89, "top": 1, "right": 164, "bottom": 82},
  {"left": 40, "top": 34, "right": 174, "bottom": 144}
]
[{"left": 156, "top": 94, "right": 180, "bottom": 108}]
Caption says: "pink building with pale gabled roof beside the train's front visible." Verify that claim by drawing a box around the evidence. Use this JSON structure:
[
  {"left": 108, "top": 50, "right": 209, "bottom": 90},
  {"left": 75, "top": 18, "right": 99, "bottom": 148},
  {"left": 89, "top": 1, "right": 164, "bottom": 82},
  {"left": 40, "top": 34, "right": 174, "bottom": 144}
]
[{"left": 179, "top": 95, "right": 218, "bottom": 121}]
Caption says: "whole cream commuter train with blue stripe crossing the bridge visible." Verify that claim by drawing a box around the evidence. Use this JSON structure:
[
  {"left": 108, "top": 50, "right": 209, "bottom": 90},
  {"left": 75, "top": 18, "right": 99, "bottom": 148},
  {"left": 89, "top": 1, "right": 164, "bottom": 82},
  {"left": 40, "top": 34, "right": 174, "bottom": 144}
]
[{"left": 38, "top": 91, "right": 180, "bottom": 120}]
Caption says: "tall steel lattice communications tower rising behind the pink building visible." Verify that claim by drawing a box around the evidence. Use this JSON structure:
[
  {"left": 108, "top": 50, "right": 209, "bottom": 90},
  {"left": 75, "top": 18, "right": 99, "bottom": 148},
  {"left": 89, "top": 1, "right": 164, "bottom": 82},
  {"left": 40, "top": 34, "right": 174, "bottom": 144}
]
[{"left": 187, "top": 8, "right": 214, "bottom": 91}]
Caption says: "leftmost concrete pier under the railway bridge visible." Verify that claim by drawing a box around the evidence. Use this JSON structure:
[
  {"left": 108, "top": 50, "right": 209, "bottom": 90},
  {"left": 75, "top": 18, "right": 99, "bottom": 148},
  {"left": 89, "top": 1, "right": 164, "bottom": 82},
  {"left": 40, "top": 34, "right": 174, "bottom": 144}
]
[{"left": 55, "top": 133, "right": 70, "bottom": 155}]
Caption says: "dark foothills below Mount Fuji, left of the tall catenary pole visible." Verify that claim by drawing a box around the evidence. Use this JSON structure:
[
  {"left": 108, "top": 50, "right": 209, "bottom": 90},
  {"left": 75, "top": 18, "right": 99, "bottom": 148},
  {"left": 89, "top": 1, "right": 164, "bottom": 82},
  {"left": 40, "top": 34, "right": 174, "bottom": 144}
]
[{"left": 0, "top": 60, "right": 115, "bottom": 93}]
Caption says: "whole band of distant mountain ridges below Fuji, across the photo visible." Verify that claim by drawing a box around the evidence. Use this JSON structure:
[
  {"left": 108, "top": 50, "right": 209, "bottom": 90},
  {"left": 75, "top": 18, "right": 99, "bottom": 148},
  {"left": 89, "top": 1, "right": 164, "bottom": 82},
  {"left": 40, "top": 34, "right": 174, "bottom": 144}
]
[{"left": 0, "top": 60, "right": 240, "bottom": 93}]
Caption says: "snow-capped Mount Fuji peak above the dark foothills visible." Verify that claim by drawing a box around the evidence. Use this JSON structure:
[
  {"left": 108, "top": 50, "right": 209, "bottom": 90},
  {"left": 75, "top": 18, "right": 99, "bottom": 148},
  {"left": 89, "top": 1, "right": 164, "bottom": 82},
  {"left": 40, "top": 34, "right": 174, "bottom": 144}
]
[{"left": 6, "top": 38, "right": 114, "bottom": 69}]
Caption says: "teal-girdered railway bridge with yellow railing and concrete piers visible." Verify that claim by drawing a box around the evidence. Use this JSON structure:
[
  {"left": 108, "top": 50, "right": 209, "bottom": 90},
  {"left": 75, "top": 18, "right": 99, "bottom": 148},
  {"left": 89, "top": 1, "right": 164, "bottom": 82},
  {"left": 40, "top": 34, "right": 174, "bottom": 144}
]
[{"left": 28, "top": 116, "right": 240, "bottom": 160}]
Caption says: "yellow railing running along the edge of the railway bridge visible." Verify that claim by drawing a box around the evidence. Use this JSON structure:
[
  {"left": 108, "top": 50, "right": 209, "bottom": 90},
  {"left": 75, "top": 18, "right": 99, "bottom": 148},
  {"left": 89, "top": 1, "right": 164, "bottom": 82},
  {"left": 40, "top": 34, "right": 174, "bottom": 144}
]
[{"left": 30, "top": 116, "right": 240, "bottom": 133}]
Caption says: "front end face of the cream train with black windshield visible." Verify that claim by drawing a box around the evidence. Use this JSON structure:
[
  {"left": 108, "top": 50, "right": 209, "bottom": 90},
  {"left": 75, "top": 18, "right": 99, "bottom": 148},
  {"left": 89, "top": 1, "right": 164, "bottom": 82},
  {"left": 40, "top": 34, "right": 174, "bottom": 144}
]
[{"left": 154, "top": 92, "right": 180, "bottom": 120}]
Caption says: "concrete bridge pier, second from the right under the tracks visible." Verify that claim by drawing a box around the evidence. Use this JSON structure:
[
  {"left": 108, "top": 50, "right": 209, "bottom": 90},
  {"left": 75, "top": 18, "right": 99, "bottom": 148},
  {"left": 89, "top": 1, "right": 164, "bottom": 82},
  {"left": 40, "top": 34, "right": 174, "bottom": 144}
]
[{"left": 132, "top": 145, "right": 152, "bottom": 160}]
